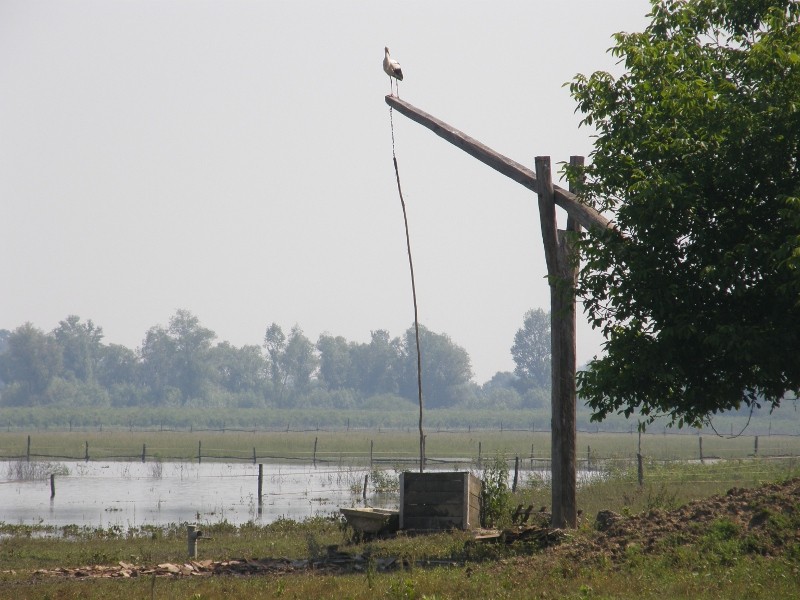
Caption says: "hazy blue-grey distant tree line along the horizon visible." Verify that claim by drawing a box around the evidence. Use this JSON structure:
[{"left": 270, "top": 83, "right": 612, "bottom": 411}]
[{"left": 0, "top": 310, "right": 550, "bottom": 409}]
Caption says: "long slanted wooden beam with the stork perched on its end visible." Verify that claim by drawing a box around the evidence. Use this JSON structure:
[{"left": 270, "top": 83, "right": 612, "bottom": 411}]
[{"left": 386, "top": 95, "right": 614, "bottom": 232}]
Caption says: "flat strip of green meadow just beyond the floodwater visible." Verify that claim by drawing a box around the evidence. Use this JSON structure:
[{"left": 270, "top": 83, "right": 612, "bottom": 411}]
[{"left": 0, "top": 430, "right": 800, "bottom": 469}]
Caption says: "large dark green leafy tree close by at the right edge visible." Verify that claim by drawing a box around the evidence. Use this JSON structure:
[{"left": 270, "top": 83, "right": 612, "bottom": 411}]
[{"left": 570, "top": 0, "right": 800, "bottom": 426}]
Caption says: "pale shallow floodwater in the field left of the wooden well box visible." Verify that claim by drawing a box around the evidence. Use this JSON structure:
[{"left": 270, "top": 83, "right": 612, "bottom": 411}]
[{"left": 0, "top": 461, "right": 399, "bottom": 529}]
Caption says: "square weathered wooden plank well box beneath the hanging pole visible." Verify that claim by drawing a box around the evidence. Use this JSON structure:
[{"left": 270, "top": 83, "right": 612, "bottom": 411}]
[{"left": 400, "top": 471, "right": 481, "bottom": 530}]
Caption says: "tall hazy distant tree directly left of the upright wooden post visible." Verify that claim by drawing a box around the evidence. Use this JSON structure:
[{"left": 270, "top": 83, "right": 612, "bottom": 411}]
[{"left": 511, "top": 308, "right": 550, "bottom": 391}]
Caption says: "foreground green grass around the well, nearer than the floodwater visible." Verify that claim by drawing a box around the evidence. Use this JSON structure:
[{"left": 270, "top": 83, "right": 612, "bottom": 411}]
[{"left": 0, "top": 460, "right": 800, "bottom": 599}]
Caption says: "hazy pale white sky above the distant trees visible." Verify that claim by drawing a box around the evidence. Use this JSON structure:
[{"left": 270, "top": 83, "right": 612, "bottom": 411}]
[{"left": 0, "top": 0, "right": 649, "bottom": 383}]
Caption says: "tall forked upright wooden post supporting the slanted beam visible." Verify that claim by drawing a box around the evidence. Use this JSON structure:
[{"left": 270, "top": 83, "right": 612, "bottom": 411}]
[{"left": 535, "top": 156, "right": 583, "bottom": 528}]
